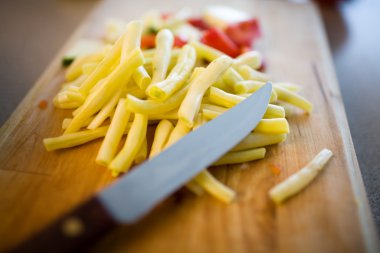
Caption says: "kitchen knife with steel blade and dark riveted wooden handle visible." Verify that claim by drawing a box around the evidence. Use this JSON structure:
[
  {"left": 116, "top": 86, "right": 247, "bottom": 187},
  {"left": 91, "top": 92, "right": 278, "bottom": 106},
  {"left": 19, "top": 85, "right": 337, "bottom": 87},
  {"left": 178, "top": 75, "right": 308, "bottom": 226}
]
[{"left": 11, "top": 83, "right": 272, "bottom": 252}]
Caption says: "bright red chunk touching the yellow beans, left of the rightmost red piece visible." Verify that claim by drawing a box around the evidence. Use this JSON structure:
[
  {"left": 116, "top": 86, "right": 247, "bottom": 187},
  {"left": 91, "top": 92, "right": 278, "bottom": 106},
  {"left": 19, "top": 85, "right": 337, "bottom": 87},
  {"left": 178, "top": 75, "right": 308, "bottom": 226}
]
[{"left": 201, "top": 28, "right": 240, "bottom": 57}]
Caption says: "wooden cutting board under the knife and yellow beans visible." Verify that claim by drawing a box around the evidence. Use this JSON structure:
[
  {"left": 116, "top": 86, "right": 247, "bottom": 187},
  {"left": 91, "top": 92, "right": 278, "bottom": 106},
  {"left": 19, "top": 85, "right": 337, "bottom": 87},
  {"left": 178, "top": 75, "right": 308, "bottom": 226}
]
[{"left": 0, "top": 0, "right": 379, "bottom": 252}]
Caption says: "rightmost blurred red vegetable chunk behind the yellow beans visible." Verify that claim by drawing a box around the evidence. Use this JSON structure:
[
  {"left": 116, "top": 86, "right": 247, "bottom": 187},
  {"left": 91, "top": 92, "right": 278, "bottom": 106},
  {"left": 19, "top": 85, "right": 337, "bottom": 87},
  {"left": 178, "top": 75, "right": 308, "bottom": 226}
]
[{"left": 226, "top": 18, "right": 261, "bottom": 48}]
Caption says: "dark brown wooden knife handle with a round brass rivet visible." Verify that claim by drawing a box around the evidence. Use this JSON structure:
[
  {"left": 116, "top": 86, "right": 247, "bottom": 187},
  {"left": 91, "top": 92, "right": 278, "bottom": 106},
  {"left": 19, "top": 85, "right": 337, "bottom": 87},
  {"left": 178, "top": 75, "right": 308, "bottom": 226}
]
[{"left": 11, "top": 197, "right": 117, "bottom": 253}]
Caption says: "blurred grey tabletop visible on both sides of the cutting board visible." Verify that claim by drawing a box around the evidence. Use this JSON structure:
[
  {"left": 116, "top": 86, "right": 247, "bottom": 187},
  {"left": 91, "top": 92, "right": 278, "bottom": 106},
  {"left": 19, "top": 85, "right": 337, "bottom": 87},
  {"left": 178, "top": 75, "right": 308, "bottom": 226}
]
[{"left": 0, "top": 0, "right": 380, "bottom": 239}]
